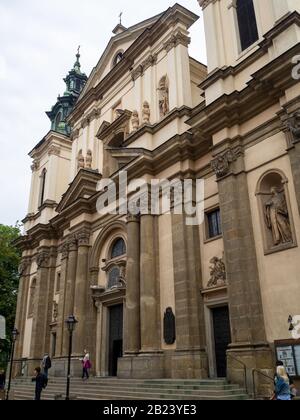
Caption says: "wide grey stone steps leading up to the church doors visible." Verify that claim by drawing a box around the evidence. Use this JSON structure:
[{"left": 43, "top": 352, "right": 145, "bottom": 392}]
[{"left": 11, "top": 378, "right": 249, "bottom": 400}]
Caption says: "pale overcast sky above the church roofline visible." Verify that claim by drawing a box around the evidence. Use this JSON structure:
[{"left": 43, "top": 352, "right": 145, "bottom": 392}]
[{"left": 0, "top": 0, "right": 206, "bottom": 225}]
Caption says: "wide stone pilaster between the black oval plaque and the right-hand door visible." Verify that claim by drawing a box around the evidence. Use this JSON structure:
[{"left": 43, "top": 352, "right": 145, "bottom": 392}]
[{"left": 172, "top": 214, "right": 208, "bottom": 379}]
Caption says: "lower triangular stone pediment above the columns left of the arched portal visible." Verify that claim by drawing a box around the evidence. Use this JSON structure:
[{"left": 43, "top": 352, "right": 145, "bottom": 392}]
[{"left": 56, "top": 169, "right": 102, "bottom": 213}]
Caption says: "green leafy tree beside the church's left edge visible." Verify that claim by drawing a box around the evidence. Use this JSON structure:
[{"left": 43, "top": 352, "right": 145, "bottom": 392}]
[{"left": 0, "top": 224, "right": 21, "bottom": 368}]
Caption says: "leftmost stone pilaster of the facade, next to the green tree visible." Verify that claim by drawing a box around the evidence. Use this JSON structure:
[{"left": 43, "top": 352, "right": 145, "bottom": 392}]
[{"left": 15, "top": 258, "right": 31, "bottom": 374}]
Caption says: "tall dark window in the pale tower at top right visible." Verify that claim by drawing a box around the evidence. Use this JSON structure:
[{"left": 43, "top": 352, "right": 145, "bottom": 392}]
[{"left": 236, "top": 0, "right": 258, "bottom": 51}]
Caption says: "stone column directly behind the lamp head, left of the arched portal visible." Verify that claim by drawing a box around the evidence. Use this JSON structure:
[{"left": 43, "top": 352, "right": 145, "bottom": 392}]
[{"left": 63, "top": 236, "right": 77, "bottom": 356}]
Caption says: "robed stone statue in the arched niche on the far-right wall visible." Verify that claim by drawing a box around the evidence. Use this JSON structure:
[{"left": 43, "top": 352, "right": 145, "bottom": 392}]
[{"left": 265, "top": 187, "right": 293, "bottom": 246}]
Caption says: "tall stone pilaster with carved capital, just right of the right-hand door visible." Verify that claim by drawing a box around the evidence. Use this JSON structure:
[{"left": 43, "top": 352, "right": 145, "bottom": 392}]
[{"left": 212, "top": 146, "right": 272, "bottom": 390}]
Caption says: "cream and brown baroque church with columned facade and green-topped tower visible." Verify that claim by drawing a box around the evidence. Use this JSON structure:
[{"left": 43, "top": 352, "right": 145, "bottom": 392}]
[{"left": 16, "top": 0, "right": 300, "bottom": 383}]
